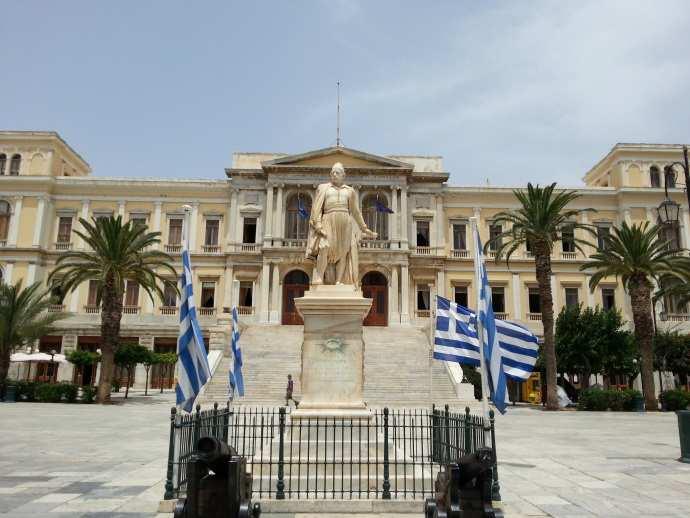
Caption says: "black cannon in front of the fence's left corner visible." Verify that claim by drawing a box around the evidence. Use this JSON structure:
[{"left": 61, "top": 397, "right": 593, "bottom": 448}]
[{"left": 174, "top": 437, "right": 261, "bottom": 518}]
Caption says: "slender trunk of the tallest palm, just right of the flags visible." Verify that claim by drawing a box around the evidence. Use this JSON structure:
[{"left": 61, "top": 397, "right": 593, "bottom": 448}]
[{"left": 534, "top": 246, "right": 558, "bottom": 410}]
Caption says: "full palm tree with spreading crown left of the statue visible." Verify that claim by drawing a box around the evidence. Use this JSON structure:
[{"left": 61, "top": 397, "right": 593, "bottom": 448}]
[{"left": 49, "top": 216, "right": 176, "bottom": 403}]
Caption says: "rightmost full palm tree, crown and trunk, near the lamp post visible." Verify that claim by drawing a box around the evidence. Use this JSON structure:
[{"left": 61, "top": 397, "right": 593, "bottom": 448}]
[{"left": 580, "top": 221, "right": 690, "bottom": 410}]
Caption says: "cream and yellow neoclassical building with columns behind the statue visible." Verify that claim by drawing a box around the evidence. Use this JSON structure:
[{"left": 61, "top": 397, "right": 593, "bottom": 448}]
[{"left": 0, "top": 131, "right": 690, "bottom": 390}]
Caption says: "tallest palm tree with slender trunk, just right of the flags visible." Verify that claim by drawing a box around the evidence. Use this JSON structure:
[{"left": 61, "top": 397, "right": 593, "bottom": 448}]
[{"left": 486, "top": 183, "right": 593, "bottom": 410}]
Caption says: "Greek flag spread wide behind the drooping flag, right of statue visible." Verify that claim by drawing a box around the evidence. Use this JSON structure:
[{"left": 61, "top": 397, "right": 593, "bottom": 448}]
[{"left": 434, "top": 297, "right": 539, "bottom": 381}]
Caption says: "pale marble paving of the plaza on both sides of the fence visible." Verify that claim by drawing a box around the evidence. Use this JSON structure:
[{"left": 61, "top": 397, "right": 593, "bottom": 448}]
[{"left": 0, "top": 394, "right": 690, "bottom": 518}]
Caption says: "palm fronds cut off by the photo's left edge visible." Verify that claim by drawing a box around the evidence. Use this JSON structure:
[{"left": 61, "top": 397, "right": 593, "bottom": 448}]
[{"left": 0, "top": 280, "right": 65, "bottom": 386}]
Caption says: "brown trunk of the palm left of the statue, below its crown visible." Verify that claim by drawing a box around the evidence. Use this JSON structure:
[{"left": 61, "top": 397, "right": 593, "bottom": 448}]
[{"left": 98, "top": 278, "right": 122, "bottom": 404}]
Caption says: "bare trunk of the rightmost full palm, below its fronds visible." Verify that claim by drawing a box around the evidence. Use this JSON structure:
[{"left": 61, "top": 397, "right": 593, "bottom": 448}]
[{"left": 628, "top": 275, "right": 659, "bottom": 411}]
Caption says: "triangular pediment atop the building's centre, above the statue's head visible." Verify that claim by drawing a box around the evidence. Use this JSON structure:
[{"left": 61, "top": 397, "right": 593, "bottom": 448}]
[{"left": 261, "top": 147, "right": 413, "bottom": 172}]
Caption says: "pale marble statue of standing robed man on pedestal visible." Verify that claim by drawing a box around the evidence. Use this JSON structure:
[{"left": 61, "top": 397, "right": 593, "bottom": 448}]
[{"left": 306, "top": 162, "right": 378, "bottom": 285}]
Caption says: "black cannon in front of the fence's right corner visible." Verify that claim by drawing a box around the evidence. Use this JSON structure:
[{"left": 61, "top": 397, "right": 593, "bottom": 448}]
[{"left": 424, "top": 448, "right": 503, "bottom": 518}]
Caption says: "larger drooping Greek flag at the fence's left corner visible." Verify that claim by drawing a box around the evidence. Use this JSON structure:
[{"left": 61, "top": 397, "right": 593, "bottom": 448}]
[{"left": 175, "top": 248, "right": 211, "bottom": 412}]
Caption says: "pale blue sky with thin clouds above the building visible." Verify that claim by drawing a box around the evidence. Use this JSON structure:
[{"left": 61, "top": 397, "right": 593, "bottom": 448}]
[{"left": 0, "top": 0, "right": 690, "bottom": 185}]
